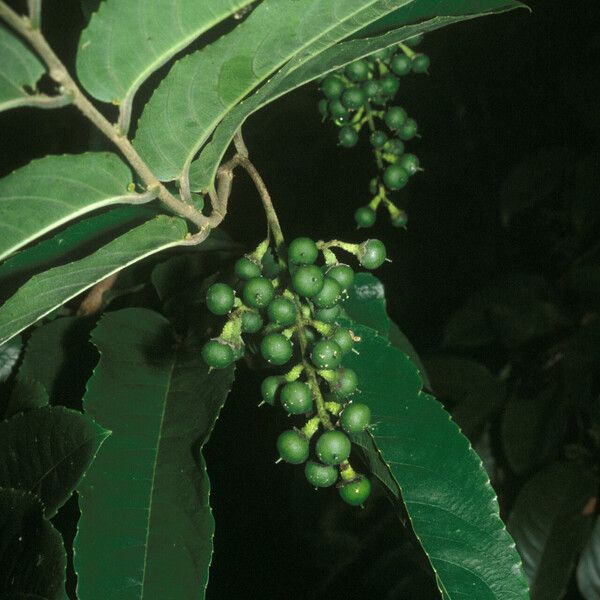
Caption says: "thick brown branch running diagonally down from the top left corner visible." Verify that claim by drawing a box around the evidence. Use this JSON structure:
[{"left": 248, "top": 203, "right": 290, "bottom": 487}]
[{"left": 0, "top": 0, "right": 210, "bottom": 230}]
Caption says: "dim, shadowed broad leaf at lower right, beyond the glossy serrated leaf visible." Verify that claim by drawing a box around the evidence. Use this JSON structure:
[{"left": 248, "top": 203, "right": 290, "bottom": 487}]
[{"left": 508, "top": 462, "right": 598, "bottom": 600}]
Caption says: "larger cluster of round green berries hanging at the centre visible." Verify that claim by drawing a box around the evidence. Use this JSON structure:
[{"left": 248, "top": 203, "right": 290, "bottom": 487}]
[{"left": 202, "top": 237, "right": 386, "bottom": 506}]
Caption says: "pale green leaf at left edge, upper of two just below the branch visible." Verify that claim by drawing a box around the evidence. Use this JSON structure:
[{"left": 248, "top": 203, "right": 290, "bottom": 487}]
[{"left": 0, "top": 152, "right": 151, "bottom": 260}]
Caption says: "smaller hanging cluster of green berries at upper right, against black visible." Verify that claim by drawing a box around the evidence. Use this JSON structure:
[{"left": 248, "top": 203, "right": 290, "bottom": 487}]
[{"left": 319, "top": 36, "right": 429, "bottom": 228}]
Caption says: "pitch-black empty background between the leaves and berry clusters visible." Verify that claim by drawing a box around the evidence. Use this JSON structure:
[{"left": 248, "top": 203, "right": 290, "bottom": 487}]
[{"left": 0, "top": 0, "right": 600, "bottom": 600}]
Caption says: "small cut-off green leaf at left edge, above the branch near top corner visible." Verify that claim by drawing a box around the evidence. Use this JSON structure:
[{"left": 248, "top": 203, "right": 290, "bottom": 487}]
[{"left": 0, "top": 25, "right": 46, "bottom": 112}]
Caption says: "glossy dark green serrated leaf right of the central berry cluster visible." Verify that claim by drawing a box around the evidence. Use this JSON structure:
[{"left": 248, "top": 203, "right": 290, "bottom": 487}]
[{"left": 346, "top": 326, "right": 528, "bottom": 600}]
